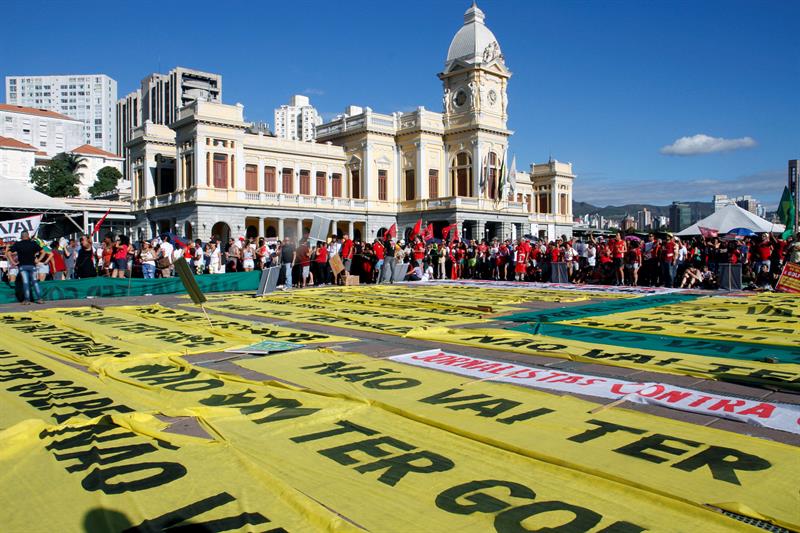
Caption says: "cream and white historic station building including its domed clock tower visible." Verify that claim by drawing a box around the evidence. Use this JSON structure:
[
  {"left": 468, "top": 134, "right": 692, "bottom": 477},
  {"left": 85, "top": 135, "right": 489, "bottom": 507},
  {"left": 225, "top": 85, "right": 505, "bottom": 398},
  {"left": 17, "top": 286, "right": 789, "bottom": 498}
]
[{"left": 127, "top": 5, "right": 575, "bottom": 240}]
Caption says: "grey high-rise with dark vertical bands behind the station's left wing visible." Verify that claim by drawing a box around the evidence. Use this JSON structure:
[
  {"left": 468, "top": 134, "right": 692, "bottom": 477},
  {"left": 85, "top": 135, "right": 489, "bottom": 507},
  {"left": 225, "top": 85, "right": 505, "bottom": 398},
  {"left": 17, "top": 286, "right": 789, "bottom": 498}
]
[{"left": 116, "top": 67, "right": 222, "bottom": 176}]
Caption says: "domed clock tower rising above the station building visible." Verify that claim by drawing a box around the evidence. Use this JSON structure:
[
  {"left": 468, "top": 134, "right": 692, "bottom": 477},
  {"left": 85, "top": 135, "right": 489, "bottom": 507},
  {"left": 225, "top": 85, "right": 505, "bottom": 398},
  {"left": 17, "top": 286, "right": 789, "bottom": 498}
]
[{"left": 439, "top": 3, "right": 512, "bottom": 198}]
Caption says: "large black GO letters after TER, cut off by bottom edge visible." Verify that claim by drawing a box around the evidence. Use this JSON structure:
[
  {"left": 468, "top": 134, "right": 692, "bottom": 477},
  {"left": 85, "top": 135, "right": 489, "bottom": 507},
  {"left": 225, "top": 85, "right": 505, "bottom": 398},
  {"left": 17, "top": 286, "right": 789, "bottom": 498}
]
[{"left": 436, "top": 479, "right": 645, "bottom": 533}]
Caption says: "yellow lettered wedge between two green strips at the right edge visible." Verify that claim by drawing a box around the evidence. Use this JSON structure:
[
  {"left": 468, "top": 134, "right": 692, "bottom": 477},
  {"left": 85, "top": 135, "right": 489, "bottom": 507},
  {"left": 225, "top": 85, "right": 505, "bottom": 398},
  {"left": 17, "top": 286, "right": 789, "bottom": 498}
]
[{"left": 561, "top": 296, "right": 800, "bottom": 347}]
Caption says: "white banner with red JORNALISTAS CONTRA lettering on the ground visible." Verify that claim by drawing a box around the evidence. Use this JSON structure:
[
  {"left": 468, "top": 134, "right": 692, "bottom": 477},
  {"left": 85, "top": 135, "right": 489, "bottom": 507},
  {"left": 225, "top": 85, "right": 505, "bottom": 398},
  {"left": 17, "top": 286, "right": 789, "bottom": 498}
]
[{"left": 389, "top": 350, "right": 800, "bottom": 434}]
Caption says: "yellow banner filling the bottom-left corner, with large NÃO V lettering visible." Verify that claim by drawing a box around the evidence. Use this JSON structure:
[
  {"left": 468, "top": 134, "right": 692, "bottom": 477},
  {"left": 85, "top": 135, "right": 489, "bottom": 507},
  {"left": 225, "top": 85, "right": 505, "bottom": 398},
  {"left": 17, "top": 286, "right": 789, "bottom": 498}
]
[{"left": 0, "top": 414, "right": 359, "bottom": 533}]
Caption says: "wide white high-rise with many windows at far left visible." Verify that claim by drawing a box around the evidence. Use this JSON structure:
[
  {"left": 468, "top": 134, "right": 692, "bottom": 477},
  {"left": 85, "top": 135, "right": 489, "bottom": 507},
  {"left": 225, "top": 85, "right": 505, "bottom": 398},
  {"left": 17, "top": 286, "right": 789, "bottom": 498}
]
[{"left": 6, "top": 74, "right": 117, "bottom": 152}]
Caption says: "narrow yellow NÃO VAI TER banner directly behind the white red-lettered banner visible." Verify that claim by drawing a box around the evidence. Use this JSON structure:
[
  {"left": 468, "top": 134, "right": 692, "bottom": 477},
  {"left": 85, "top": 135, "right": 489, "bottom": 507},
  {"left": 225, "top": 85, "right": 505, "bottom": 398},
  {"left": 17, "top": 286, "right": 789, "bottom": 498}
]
[{"left": 406, "top": 327, "right": 800, "bottom": 390}]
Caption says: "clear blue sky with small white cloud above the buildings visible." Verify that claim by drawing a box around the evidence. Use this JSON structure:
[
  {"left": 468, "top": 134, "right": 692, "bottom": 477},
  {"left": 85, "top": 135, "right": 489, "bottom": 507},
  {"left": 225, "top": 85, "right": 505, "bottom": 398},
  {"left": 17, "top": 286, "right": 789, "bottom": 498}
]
[{"left": 0, "top": 0, "right": 800, "bottom": 206}]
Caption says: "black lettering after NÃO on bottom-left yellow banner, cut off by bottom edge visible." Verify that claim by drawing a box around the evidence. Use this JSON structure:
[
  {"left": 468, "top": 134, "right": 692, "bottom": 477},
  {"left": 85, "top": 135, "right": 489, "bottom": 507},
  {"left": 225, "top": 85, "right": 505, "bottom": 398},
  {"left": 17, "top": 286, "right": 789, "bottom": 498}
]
[{"left": 123, "top": 492, "right": 276, "bottom": 533}]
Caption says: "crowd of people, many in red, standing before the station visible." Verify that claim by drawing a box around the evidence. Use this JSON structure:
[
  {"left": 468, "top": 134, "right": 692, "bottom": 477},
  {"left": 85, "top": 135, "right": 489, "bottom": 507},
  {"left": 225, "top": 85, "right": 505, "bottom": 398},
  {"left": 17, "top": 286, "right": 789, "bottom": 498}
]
[{"left": 0, "top": 227, "right": 800, "bottom": 301}]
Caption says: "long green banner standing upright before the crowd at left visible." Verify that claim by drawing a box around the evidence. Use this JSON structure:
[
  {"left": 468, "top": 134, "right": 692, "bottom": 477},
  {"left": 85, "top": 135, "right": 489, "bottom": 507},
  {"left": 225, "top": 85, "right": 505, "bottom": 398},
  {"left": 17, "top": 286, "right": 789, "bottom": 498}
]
[{"left": 0, "top": 271, "right": 261, "bottom": 304}]
